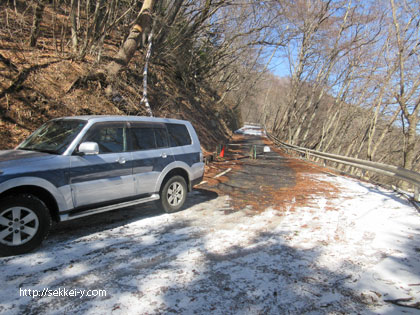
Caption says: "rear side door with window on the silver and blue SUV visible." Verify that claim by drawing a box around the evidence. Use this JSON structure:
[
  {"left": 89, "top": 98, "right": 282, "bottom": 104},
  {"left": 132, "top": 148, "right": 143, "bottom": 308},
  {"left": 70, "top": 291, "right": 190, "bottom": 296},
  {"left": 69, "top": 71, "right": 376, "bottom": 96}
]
[{"left": 130, "top": 122, "right": 174, "bottom": 195}]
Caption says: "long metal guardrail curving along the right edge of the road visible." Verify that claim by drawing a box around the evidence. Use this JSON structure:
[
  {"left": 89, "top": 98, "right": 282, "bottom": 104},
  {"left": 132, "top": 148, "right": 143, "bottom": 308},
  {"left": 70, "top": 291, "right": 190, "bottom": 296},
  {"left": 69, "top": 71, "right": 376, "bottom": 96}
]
[{"left": 267, "top": 133, "right": 420, "bottom": 202}]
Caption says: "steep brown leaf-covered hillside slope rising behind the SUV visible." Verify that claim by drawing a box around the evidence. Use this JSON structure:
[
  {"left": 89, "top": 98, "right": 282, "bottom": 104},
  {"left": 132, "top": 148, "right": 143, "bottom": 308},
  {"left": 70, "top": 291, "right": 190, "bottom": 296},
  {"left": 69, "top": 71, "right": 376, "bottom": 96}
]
[{"left": 0, "top": 5, "right": 237, "bottom": 150}]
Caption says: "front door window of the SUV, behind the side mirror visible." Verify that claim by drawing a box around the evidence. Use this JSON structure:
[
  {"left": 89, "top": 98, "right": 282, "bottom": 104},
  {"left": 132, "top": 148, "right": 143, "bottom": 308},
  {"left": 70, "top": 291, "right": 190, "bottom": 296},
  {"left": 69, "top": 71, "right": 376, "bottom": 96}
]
[{"left": 83, "top": 124, "right": 127, "bottom": 153}]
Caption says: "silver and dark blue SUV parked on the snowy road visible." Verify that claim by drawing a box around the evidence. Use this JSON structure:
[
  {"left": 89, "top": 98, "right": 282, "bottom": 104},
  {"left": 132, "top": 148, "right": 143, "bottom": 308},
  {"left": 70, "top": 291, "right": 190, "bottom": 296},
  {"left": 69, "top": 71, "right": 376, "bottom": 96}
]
[{"left": 0, "top": 116, "right": 204, "bottom": 256}]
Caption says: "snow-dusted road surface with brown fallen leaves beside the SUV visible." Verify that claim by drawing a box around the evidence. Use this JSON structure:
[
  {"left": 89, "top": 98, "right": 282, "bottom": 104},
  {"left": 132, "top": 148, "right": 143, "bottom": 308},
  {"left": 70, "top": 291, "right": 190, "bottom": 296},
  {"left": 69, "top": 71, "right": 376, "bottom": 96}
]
[{"left": 0, "top": 138, "right": 420, "bottom": 314}]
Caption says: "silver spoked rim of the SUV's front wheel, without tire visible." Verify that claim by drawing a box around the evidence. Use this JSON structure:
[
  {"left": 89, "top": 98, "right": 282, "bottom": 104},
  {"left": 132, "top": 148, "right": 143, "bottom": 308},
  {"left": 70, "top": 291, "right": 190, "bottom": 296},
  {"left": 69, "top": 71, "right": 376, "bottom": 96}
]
[{"left": 0, "top": 207, "right": 39, "bottom": 246}]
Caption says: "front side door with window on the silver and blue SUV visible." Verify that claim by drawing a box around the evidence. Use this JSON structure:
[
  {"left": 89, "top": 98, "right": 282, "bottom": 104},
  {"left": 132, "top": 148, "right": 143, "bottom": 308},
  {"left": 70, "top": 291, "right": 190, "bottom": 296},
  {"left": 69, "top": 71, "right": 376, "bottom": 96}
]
[{"left": 70, "top": 122, "right": 135, "bottom": 208}]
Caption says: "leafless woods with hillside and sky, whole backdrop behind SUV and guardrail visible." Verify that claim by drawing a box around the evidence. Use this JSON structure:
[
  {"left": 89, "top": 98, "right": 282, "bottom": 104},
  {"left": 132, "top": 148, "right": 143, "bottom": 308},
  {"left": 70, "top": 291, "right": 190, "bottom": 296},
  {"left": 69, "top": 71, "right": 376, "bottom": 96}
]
[{"left": 0, "top": 0, "right": 420, "bottom": 178}]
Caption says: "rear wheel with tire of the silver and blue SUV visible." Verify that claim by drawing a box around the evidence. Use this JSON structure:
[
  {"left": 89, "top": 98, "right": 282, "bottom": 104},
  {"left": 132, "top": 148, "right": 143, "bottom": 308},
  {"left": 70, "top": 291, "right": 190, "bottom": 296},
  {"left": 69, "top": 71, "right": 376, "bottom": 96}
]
[{"left": 159, "top": 176, "right": 188, "bottom": 213}]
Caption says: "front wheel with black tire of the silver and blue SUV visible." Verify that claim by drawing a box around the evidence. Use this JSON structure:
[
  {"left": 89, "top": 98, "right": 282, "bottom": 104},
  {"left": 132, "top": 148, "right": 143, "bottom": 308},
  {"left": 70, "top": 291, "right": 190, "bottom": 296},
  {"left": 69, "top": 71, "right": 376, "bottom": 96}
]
[{"left": 0, "top": 194, "right": 52, "bottom": 256}]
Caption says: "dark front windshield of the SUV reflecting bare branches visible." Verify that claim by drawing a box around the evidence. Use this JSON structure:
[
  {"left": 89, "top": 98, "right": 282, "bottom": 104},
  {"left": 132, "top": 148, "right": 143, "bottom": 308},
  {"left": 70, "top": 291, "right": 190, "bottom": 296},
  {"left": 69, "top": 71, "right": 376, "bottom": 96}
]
[{"left": 18, "top": 119, "right": 86, "bottom": 154}]
